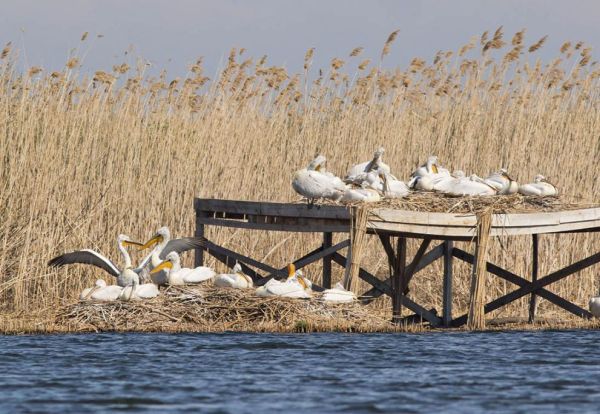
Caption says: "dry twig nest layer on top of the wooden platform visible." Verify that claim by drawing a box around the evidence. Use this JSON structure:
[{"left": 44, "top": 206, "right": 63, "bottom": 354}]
[{"left": 314, "top": 191, "right": 600, "bottom": 214}]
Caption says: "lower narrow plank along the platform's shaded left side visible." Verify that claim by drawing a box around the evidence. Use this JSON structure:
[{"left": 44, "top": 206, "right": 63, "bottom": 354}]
[{"left": 197, "top": 217, "right": 350, "bottom": 233}]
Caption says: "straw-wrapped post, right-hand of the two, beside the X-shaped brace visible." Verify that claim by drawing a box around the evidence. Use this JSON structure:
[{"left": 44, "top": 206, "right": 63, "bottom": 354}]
[{"left": 467, "top": 212, "right": 492, "bottom": 329}]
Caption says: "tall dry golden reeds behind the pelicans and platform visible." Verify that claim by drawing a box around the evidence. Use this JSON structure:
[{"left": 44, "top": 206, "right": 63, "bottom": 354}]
[{"left": 0, "top": 28, "right": 600, "bottom": 332}]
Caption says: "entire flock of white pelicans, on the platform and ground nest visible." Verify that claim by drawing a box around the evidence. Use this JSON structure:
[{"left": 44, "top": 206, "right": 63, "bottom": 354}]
[{"left": 48, "top": 147, "right": 560, "bottom": 308}]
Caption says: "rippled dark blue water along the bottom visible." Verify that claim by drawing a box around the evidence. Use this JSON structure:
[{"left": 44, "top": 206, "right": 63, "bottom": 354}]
[{"left": 0, "top": 331, "right": 600, "bottom": 414}]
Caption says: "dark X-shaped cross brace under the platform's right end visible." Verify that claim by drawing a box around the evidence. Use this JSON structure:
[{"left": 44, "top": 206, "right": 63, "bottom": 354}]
[{"left": 452, "top": 247, "right": 600, "bottom": 326}]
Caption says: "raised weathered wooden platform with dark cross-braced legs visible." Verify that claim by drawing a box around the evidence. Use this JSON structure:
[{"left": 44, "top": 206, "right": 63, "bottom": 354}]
[{"left": 194, "top": 198, "right": 600, "bottom": 327}]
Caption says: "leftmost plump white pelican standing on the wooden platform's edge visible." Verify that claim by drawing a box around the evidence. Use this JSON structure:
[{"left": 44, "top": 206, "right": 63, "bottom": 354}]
[{"left": 292, "top": 155, "right": 346, "bottom": 205}]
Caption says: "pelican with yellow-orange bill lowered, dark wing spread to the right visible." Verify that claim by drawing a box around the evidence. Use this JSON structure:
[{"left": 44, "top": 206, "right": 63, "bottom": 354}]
[{"left": 139, "top": 226, "right": 203, "bottom": 285}]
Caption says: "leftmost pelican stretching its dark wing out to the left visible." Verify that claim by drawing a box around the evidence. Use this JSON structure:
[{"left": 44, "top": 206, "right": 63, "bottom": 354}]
[{"left": 48, "top": 234, "right": 142, "bottom": 286}]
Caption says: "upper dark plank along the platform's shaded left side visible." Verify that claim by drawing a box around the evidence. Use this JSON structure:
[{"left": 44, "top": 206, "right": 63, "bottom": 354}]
[{"left": 194, "top": 198, "right": 350, "bottom": 220}]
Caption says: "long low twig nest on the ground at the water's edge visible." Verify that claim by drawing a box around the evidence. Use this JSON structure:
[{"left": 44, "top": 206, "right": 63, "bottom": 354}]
[{"left": 56, "top": 286, "right": 397, "bottom": 332}]
